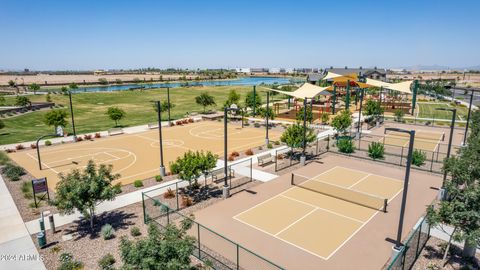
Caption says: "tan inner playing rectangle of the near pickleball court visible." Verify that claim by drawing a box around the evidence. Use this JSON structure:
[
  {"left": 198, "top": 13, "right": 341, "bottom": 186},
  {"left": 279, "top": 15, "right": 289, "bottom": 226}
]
[{"left": 234, "top": 166, "right": 403, "bottom": 260}]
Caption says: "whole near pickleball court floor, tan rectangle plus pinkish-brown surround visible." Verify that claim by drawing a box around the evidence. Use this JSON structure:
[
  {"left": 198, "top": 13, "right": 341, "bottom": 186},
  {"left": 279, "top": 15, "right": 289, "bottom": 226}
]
[{"left": 194, "top": 154, "right": 442, "bottom": 270}]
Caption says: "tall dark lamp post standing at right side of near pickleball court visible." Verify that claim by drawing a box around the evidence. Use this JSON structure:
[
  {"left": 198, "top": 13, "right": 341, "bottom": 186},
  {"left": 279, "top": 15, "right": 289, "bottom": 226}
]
[{"left": 385, "top": 128, "right": 415, "bottom": 253}]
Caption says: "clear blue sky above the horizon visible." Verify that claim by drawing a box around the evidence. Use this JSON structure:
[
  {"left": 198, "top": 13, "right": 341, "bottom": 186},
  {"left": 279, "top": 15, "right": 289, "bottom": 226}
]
[{"left": 0, "top": 0, "right": 480, "bottom": 70}]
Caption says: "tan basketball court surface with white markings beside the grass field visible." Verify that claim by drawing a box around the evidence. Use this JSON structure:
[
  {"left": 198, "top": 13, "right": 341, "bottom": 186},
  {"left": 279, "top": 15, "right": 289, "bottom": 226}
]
[{"left": 9, "top": 121, "right": 280, "bottom": 189}]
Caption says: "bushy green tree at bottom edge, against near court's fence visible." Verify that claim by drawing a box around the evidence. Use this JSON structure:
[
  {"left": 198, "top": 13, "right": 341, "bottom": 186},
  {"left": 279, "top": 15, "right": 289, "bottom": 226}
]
[{"left": 120, "top": 219, "right": 196, "bottom": 270}]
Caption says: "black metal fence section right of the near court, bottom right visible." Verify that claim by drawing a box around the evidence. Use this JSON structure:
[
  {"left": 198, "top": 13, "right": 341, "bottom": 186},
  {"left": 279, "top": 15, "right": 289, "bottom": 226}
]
[{"left": 386, "top": 218, "right": 430, "bottom": 270}]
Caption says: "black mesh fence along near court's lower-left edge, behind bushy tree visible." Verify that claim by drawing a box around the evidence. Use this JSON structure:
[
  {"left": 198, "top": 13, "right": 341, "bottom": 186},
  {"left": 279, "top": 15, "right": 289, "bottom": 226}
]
[{"left": 142, "top": 193, "right": 284, "bottom": 270}]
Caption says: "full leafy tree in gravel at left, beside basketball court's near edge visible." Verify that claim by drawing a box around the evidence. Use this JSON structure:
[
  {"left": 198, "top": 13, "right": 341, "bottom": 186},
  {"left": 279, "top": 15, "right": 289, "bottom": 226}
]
[{"left": 53, "top": 160, "right": 121, "bottom": 229}]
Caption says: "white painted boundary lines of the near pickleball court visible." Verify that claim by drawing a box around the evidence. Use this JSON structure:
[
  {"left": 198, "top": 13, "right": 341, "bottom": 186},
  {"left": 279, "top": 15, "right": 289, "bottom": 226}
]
[{"left": 233, "top": 165, "right": 403, "bottom": 260}]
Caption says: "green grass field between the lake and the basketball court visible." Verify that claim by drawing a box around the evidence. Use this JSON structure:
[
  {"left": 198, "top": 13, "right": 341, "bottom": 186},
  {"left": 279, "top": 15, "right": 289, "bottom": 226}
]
[{"left": 0, "top": 86, "right": 280, "bottom": 144}]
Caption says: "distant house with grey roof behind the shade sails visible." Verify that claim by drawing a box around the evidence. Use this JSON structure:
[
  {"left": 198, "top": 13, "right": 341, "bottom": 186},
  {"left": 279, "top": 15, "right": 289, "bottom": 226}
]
[{"left": 307, "top": 67, "right": 387, "bottom": 84}]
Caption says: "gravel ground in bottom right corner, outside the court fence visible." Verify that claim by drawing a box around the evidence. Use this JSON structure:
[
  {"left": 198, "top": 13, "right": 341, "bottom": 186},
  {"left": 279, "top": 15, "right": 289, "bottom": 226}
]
[{"left": 412, "top": 237, "right": 480, "bottom": 270}]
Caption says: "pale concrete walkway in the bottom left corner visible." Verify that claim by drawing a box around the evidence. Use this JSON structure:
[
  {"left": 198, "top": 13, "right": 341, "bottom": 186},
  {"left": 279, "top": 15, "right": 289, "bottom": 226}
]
[{"left": 0, "top": 176, "right": 46, "bottom": 270}]
